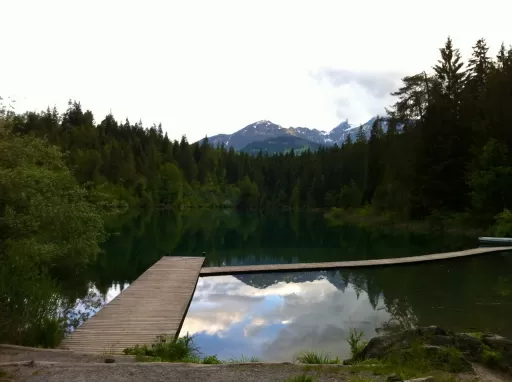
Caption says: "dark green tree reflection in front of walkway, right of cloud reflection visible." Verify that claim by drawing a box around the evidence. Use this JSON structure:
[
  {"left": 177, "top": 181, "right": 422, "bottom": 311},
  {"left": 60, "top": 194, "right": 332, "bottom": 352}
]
[{"left": 355, "top": 254, "right": 512, "bottom": 335}]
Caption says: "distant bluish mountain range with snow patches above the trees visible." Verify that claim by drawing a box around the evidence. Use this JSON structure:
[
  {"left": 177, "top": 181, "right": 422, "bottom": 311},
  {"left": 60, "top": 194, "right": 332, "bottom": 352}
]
[{"left": 202, "top": 117, "right": 387, "bottom": 154}]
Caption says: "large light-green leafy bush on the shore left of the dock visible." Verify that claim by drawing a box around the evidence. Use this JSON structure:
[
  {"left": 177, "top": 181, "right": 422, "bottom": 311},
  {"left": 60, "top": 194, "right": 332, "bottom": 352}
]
[{"left": 0, "top": 120, "right": 105, "bottom": 347}]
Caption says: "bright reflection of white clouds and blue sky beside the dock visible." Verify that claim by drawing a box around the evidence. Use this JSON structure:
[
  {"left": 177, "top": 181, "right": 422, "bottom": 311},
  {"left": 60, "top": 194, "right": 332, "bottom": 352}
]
[{"left": 182, "top": 273, "right": 390, "bottom": 361}]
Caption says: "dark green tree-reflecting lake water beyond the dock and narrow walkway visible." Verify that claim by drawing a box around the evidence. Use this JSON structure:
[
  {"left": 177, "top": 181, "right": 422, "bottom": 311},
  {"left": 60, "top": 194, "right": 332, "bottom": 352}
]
[{"left": 84, "top": 209, "right": 476, "bottom": 290}]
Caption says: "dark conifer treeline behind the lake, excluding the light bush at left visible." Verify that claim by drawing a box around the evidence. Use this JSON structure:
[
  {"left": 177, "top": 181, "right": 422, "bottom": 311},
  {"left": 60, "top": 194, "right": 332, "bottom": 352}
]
[{"left": 3, "top": 39, "right": 512, "bottom": 224}]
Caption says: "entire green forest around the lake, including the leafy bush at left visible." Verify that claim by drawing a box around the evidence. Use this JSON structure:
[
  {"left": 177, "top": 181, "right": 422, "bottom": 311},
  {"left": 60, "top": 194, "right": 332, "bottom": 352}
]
[{"left": 0, "top": 39, "right": 512, "bottom": 346}]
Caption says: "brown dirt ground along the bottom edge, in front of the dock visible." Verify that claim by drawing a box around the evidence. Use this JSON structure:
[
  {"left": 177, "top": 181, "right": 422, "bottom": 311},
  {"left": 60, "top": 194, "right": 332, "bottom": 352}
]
[{"left": 0, "top": 345, "right": 510, "bottom": 382}]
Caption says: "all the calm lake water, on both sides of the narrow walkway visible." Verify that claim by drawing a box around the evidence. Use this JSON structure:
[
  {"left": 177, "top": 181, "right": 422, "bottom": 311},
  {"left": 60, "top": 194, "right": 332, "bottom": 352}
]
[{"left": 76, "top": 210, "right": 512, "bottom": 361}]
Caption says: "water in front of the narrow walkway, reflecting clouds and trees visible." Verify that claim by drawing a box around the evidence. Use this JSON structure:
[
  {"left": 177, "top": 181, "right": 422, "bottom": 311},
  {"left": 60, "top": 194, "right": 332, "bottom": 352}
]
[{"left": 181, "top": 253, "right": 512, "bottom": 361}]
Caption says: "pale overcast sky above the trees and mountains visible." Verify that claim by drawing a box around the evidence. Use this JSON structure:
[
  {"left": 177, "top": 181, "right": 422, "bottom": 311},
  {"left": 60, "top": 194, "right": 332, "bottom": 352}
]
[{"left": 0, "top": 0, "right": 512, "bottom": 141}]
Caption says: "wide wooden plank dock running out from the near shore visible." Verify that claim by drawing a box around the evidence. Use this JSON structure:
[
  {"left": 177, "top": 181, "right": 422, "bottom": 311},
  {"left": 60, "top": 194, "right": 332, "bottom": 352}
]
[{"left": 61, "top": 257, "right": 204, "bottom": 354}]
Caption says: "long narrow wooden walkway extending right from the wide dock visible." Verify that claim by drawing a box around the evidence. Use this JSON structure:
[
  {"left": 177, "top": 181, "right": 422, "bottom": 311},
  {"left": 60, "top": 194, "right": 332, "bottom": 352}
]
[{"left": 200, "top": 247, "right": 512, "bottom": 276}]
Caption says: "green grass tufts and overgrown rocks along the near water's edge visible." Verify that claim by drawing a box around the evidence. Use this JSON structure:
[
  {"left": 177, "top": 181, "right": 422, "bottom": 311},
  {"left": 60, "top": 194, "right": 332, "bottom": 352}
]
[{"left": 125, "top": 328, "right": 510, "bottom": 381}]
